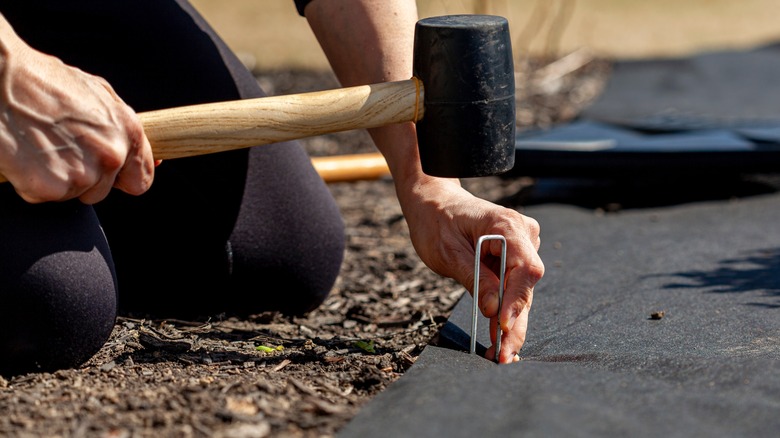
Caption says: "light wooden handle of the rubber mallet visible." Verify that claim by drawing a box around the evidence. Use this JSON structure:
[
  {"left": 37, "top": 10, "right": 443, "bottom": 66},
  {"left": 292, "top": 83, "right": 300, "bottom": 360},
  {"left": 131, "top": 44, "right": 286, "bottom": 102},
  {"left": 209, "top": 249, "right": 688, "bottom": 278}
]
[{"left": 0, "top": 78, "right": 424, "bottom": 182}]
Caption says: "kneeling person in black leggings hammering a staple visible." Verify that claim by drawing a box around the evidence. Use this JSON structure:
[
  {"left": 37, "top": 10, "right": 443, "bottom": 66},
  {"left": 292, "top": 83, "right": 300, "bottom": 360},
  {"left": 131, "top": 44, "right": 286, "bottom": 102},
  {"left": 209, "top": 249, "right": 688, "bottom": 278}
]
[{"left": 0, "top": 0, "right": 544, "bottom": 375}]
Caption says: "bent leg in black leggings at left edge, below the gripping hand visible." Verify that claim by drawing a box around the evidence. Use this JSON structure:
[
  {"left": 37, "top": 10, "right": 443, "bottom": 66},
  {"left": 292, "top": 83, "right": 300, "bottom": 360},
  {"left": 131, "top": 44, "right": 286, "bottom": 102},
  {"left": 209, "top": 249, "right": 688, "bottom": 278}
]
[{"left": 0, "top": 184, "right": 116, "bottom": 375}]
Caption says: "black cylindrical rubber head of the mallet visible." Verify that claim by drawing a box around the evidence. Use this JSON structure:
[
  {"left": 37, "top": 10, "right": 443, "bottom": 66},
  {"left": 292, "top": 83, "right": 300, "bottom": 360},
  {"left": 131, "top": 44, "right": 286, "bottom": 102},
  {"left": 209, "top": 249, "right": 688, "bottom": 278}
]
[{"left": 414, "top": 15, "right": 516, "bottom": 178}]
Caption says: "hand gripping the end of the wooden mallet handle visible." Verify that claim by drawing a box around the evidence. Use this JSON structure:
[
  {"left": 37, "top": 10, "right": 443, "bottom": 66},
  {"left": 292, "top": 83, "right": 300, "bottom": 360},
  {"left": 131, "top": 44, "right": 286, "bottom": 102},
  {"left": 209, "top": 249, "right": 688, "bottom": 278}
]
[{"left": 0, "top": 20, "right": 154, "bottom": 204}]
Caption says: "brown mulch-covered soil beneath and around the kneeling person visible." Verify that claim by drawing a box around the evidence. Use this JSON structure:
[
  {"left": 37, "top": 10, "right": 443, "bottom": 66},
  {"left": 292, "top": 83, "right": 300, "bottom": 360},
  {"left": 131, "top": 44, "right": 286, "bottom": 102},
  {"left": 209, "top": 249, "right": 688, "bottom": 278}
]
[{"left": 0, "top": 59, "right": 609, "bottom": 437}]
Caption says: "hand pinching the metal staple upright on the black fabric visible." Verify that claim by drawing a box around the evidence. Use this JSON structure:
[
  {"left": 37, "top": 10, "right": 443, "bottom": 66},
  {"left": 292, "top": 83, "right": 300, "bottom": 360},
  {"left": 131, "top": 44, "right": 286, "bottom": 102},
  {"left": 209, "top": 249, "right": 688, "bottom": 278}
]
[{"left": 399, "top": 178, "right": 544, "bottom": 363}]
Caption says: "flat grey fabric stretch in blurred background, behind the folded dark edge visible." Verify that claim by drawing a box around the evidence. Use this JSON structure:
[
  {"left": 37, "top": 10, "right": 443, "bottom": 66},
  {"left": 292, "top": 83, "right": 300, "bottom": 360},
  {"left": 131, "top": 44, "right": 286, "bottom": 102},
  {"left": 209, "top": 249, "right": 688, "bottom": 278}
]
[{"left": 582, "top": 43, "right": 780, "bottom": 131}]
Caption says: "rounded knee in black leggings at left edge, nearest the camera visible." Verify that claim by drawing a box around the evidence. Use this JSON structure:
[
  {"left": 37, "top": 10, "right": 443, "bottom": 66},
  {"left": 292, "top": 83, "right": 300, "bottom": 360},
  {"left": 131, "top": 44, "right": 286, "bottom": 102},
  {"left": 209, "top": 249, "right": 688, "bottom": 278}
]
[{"left": 0, "top": 253, "right": 116, "bottom": 375}]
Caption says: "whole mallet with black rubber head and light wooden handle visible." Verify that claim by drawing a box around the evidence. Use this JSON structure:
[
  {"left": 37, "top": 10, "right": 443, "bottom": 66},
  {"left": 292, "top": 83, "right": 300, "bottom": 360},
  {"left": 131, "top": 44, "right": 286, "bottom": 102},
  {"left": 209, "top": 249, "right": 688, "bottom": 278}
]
[{"left": 0, "top": 15, "right": 516, "bottom": 183}]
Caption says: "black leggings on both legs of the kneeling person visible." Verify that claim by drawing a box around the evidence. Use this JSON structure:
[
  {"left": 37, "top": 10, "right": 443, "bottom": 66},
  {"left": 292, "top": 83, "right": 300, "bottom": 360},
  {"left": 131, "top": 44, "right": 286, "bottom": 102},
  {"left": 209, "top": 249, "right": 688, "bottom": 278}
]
[{"left": 0, "top": 0, "right": 344, "bottom": 375}]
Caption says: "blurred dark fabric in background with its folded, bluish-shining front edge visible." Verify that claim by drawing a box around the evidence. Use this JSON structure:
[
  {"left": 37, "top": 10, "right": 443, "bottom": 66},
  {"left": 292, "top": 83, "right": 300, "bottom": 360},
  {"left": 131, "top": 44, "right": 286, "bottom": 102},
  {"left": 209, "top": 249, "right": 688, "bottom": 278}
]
[{"left": 510, "top": 44, "right": 780, "bottom": 178}]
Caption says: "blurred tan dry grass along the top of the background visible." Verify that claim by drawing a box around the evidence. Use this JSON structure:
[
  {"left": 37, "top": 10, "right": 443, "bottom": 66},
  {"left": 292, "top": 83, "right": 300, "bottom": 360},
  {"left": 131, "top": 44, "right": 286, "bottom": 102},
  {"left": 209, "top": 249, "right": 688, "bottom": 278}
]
[{"left": 191, "top": 0, "right": 780, "bottom": 70}]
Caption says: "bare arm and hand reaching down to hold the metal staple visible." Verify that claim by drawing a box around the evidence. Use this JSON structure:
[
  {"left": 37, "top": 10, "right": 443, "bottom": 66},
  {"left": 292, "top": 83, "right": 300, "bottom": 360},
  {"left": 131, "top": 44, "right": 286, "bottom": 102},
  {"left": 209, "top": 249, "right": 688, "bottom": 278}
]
[{"left": 306, "top": 0, "right": 544, "bottom": 362}]
